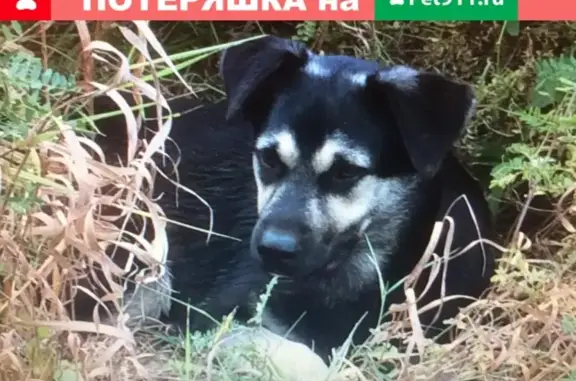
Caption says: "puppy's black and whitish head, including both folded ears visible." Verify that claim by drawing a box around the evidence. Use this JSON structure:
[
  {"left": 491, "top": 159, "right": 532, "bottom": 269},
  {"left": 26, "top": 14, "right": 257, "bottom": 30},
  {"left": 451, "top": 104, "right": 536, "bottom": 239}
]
[{"left": 221, "top": 36, "right": 474, "bottom": 297}]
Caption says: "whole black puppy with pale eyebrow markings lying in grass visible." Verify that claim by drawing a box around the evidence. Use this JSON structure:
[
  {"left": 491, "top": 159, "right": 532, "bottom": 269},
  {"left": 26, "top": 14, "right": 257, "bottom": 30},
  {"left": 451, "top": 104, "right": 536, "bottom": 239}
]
[{"left": 88, "top": 36, "right": 497, "bottom": 361}]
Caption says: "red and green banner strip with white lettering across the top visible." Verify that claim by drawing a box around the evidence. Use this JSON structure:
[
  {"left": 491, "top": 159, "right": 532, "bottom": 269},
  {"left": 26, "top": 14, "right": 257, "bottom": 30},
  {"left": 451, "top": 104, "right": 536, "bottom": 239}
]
[{"left": 0, "top": 0, "right": 576, "bottom": 21}]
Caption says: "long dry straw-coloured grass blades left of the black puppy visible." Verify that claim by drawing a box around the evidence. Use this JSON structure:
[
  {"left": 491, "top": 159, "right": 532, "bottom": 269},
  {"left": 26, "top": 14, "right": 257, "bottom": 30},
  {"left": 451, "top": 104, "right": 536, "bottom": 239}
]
[{"left": 0, "top": 21, "right": 215, "bottom": 380}]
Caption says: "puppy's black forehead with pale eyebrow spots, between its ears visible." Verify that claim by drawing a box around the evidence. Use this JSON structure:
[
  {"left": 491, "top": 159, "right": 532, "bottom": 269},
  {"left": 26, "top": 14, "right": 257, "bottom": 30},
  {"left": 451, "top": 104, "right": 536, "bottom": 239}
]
[{"left": 257, "top": 55, "right": 408, "bottom": 170}]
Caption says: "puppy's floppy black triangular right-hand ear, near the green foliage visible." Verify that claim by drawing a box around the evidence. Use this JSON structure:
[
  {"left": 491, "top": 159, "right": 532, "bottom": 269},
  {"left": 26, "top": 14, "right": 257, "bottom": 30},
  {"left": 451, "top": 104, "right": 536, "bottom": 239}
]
[{"left": 366, "top": 66, "right": 476, "bottom": 176}]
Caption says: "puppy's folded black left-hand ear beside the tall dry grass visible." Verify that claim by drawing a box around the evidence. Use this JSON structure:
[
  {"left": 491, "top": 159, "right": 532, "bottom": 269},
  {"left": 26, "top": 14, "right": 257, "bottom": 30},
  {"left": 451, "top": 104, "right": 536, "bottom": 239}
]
[{"left": 220, "top": 36, "right": 308, "bottom": 123}]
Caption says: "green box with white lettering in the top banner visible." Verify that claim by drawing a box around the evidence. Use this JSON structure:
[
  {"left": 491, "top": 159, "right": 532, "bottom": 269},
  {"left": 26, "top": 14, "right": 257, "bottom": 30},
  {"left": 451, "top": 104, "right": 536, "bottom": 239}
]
[{"left": 375, "top": 0, "right": 518, "bottom": 21}]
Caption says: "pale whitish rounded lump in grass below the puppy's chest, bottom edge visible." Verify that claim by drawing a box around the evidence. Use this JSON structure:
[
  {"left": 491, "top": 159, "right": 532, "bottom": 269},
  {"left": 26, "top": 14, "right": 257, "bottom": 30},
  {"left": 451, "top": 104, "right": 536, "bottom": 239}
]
[{"left": 216, "top": 327, "right": 329, "bottom": 381}]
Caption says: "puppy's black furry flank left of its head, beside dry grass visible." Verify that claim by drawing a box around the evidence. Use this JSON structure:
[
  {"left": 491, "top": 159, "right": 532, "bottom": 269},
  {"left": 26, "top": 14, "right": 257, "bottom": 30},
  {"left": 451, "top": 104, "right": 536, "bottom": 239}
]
[{"left": 157, "top": 99, "right": 268, "bottom": 330}]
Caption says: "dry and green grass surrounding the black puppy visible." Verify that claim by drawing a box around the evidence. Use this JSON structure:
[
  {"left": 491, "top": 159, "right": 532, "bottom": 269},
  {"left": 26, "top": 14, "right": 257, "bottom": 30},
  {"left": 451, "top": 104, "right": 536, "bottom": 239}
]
[{"left": 0, "top": 21, "right": 576, "bottom": 381}]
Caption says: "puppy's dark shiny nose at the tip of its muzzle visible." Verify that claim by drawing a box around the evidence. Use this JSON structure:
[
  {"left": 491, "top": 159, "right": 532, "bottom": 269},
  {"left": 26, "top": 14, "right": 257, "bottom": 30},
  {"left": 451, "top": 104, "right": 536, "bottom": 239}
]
[{"left": 257, "top": 228, "right": 299, "bottom": 273}]
